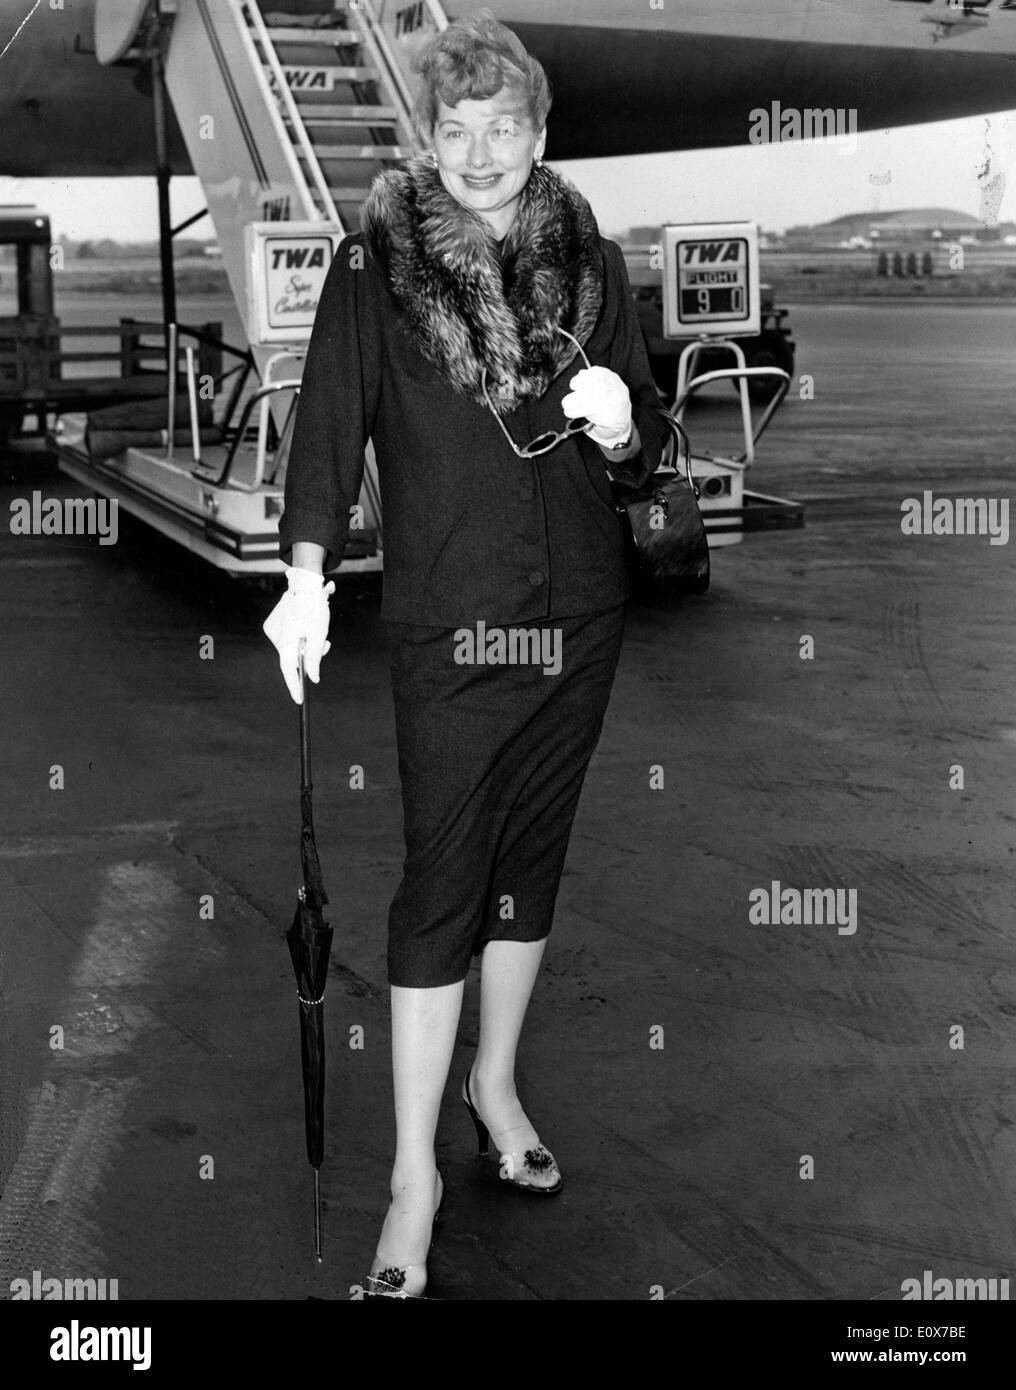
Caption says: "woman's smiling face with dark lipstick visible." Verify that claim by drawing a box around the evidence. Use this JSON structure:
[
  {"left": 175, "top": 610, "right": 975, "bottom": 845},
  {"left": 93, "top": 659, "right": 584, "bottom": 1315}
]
[{"left": 434, "top": 85, "right": 546, "bottom": 238}]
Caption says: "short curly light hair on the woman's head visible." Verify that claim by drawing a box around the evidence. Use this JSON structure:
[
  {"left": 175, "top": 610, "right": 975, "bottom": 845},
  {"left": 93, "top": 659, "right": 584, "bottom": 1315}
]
[{"left": 413, "top": 10, "right": 552, "bottom": 147}]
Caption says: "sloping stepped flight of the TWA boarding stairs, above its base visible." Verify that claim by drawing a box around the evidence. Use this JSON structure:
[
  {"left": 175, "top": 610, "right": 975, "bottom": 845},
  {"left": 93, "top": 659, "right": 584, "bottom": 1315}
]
[{"left": 165, "top": 0, "right": 448, "bottom": 322}]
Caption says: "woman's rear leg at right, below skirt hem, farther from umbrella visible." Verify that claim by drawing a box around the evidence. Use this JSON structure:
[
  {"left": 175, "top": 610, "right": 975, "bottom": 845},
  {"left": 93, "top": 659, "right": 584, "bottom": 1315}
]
[{"left": 470, "top": 938, "right": 549, "bottom": 1167}]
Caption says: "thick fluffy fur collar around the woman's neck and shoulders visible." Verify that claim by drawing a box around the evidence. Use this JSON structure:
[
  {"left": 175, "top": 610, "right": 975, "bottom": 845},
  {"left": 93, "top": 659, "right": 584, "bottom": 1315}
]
[{"left": 361, "top": 157, "right": 603, "bottom": 411}]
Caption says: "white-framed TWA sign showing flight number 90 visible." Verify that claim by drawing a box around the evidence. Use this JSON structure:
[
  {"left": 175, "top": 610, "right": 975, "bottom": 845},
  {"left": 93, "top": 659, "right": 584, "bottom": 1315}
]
[{"left": 663, "top": 222, "right": 762, "bottom": 338}]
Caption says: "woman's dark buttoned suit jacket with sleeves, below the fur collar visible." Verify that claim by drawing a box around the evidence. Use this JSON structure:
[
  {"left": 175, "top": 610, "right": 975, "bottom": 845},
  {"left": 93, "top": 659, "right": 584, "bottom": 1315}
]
[{"left": 279, "top": 236, "right": 666, "bottom": 627}]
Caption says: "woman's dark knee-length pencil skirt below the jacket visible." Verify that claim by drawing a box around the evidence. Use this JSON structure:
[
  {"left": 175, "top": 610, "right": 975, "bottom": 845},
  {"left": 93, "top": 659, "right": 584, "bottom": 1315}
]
[{"left": 385, "top": 603, "right": 627, "bottom": 988}]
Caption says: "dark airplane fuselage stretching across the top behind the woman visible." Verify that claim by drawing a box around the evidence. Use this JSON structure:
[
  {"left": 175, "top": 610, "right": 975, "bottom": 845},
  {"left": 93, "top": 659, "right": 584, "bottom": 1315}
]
[{"left": 0, "top": 0, "right": 1016, "bottom": 178}]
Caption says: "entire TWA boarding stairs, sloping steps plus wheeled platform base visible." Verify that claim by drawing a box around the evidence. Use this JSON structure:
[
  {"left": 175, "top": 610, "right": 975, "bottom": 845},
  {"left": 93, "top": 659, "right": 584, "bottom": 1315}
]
[{"left": 63, "top": 0, "right": 448, "bottom": 574}]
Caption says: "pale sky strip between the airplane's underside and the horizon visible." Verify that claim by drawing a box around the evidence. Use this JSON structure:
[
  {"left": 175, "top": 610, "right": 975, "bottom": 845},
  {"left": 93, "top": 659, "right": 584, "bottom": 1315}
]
[{"left": 0, "top": 111, "right": 1016, "bottom": 242}]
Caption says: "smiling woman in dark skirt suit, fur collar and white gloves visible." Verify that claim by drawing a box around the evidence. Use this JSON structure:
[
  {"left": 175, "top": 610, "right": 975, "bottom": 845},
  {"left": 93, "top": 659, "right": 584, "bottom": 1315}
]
[{"left": 265, "top": 10, "right": 664, "bottom": 1297}]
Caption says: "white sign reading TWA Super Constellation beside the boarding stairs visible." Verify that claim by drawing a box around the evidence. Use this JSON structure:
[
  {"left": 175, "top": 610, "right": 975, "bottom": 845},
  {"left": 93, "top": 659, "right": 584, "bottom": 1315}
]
[{"left": 247, "top": 222, "right": 341, "bottom": 343}]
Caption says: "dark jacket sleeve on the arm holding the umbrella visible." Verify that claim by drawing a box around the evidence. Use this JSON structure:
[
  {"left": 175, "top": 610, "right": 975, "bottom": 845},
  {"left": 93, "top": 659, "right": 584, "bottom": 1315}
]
[{"left": 279, "top": 238, "right": 381, "bottom": 570}]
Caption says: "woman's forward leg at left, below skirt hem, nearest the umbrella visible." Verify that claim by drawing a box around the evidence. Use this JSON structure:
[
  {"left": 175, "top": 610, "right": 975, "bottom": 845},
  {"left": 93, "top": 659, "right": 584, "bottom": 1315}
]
[{"left": 371, "top": 980, "right": 464, "bottom": 1293}]
